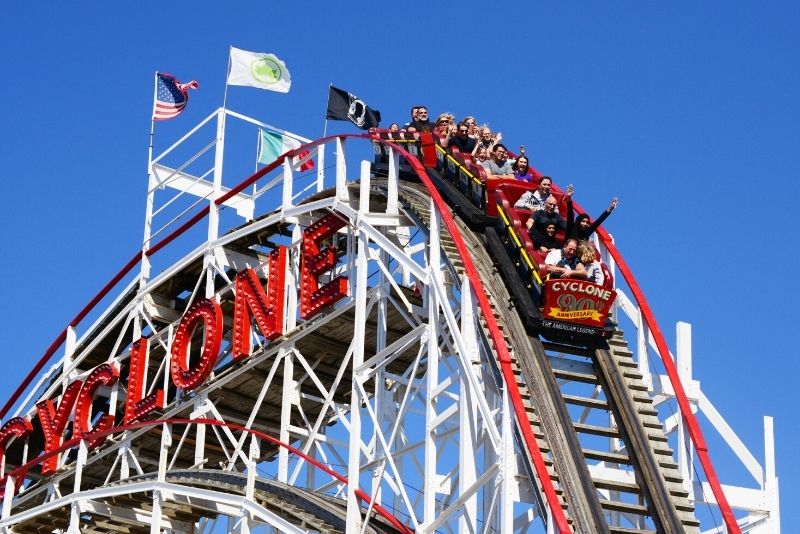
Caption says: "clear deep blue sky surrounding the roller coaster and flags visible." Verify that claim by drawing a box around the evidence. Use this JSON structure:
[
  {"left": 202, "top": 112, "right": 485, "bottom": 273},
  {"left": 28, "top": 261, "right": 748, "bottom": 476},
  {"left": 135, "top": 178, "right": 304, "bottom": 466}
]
[{"left": 0, "top": 0, "right": 800, "bottom": 532}]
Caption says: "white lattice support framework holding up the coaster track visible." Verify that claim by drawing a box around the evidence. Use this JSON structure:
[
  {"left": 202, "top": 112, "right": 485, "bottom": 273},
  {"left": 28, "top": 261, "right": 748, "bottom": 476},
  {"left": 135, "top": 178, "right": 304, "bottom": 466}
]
[{"left": 0, "top": 109, "right": 779, "bottom": 533}]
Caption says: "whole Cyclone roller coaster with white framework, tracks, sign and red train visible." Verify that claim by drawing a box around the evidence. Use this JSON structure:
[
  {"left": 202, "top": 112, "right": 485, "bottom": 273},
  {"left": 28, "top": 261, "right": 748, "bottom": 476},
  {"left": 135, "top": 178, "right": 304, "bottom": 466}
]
[{"left": 0, "top": 109, "right": 780, "bottom": 534}]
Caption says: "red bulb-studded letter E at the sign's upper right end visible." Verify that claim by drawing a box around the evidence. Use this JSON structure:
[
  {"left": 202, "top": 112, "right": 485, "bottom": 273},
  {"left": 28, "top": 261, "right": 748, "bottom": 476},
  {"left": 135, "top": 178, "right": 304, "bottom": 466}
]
[{"left": 300, "top": 213, "right": 347, "bottom": 319}]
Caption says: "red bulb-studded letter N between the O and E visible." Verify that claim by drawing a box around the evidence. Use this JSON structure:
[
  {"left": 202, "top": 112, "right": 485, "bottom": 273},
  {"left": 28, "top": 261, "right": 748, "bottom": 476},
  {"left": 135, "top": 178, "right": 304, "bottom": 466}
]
[{"left": 233, "top": 247, "right": 286, "bottom": 361}]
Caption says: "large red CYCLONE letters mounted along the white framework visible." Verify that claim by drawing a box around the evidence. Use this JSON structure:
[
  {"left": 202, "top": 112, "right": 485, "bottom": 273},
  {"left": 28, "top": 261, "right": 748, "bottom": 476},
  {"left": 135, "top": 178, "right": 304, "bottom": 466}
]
[{"left": 0, "top": 212, "right": 350, "bottom": 502}]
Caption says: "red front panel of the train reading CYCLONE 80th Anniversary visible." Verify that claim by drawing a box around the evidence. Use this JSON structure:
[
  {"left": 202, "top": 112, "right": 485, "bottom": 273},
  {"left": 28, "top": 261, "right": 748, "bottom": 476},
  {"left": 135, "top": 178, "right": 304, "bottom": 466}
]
[{"left": 544, "top": 279, "right": 617, "bottom": 327}]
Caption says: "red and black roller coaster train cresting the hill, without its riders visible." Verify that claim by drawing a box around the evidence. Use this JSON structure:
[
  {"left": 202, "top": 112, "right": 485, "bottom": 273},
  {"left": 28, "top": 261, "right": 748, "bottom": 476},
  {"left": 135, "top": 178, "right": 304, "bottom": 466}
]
[{"left": 371, "top": 130, "right": 616, "bottom": 346}]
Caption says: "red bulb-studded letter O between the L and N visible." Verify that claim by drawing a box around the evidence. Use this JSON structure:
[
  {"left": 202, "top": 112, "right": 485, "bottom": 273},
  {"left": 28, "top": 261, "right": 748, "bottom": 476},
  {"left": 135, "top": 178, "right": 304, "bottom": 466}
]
[{"left": 170, "top": 298, "right": 222, "bottom": 390}]
